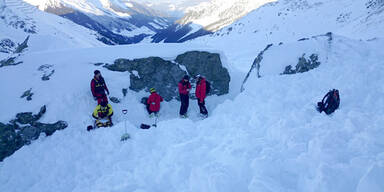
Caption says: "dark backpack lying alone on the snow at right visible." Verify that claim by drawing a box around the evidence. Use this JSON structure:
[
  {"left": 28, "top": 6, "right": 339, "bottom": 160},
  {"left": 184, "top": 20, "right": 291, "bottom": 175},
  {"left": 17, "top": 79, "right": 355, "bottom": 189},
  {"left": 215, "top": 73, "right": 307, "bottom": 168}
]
[{"left": 317, "top": 89, "right": 340, "bottom": 115}]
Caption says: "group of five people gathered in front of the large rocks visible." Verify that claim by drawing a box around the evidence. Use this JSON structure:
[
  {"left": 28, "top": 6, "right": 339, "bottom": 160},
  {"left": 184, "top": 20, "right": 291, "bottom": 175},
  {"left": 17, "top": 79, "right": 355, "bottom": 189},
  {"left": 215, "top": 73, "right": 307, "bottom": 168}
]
[{"left": 91, "top": 70, "right": 208, "bottom": 127}]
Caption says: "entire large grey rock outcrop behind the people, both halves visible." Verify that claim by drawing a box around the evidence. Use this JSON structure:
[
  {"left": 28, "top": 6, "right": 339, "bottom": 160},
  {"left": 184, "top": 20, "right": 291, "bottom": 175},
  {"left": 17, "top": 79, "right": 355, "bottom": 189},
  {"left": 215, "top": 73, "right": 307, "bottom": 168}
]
[{"left": 104, "top": 51, "right": 230, "bottom": 101}]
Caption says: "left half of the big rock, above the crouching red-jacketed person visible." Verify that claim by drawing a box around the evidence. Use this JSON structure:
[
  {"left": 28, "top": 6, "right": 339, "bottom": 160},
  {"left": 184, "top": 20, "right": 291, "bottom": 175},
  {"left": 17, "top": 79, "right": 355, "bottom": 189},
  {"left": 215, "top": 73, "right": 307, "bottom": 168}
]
[{"left": 104, "top": 57, "right": 186, "bottom": 101}]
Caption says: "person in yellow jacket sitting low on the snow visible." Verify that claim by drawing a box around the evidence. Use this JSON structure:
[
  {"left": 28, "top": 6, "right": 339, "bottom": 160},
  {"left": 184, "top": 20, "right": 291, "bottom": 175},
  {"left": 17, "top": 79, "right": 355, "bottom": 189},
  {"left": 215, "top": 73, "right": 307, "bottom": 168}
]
[{"left": 92, "top": 101, "right": 113, "bottom": 127}]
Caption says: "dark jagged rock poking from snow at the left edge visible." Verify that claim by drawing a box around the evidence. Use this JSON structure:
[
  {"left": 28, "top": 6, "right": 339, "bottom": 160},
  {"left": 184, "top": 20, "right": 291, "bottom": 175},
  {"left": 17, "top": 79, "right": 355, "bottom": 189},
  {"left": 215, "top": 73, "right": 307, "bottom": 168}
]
[{"left": 0, "top": 106, "right": 68, "bottom": 161}]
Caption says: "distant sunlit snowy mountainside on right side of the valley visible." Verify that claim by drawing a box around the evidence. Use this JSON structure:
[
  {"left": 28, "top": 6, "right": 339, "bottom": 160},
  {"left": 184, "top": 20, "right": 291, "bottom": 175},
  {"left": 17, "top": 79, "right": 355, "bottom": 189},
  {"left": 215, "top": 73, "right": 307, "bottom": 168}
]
[{"left": 153, "top": 0, "right": 274, "bottom": 42}]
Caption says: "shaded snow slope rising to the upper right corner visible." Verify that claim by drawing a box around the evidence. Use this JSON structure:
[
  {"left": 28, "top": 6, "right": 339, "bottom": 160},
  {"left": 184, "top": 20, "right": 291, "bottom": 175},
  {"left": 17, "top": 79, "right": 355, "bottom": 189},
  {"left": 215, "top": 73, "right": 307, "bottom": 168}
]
[{"left": 194, "top": 0, "right": 384, "bottom": 71}]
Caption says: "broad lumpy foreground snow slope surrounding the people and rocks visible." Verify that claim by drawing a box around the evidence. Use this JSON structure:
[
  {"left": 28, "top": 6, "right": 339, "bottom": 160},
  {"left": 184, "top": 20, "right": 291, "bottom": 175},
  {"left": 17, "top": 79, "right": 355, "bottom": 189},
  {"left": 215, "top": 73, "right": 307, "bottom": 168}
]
[{"left": 0, "top": 32, "right": 384, "bottom": 192}]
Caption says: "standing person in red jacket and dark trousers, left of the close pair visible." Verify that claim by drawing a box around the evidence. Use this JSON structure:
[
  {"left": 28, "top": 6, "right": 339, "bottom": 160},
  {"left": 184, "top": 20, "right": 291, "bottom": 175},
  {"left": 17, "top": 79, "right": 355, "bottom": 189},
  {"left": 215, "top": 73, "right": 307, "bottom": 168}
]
[{"left": 178, "top": 75, "right": 191, "bottom": 118}]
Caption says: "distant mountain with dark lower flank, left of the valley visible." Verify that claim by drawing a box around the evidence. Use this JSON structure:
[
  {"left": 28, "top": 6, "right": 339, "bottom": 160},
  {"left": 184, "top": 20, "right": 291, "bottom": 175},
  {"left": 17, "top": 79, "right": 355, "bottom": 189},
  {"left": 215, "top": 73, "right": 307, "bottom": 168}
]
[{"left": 25, "top": 0, "right": 172, "bottom": 45}]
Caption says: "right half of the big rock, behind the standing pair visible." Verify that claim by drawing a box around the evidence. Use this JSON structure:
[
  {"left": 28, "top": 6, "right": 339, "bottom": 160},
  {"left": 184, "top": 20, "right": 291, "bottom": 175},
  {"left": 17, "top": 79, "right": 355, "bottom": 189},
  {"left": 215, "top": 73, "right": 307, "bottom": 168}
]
[{"left": 176, "top": 51, "right": 231, "bottom": 95}]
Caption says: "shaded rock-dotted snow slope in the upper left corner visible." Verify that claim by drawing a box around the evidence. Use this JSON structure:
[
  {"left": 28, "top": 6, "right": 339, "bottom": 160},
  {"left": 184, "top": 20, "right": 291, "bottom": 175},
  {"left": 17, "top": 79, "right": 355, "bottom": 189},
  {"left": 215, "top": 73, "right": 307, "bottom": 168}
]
[{"left": 0, "top": 0, "right": 102, "bottom": 51}]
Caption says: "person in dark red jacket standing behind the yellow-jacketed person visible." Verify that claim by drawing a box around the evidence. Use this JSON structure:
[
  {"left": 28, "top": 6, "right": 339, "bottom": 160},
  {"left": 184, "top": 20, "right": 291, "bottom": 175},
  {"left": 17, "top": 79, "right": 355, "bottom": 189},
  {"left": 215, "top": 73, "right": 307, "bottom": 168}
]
[{"left": 91, "top": 70, "right": 109, "bottom": 105}]
